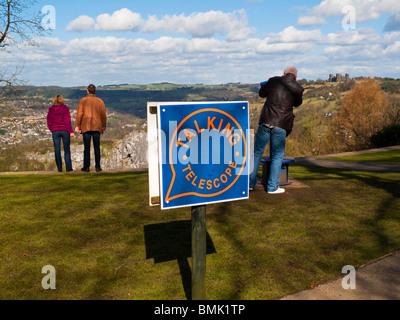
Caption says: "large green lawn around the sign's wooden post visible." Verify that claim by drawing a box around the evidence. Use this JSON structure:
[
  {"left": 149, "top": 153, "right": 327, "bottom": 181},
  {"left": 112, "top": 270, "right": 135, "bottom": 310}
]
[{"left": 0, "top": 166, "right": 400, "bottom": 300}]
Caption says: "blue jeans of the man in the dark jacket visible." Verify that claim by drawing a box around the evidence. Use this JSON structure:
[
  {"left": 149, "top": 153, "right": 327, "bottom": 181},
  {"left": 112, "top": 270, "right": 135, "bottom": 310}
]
[{"left": 250, "top": 124, "right": 286, "bottom": 192}]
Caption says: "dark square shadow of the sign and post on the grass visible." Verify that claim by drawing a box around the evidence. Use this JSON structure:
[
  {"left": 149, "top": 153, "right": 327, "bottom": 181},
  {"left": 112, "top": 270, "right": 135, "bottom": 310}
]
[{"left": 144, "top": 220, "right": 216, "bottom": 300}]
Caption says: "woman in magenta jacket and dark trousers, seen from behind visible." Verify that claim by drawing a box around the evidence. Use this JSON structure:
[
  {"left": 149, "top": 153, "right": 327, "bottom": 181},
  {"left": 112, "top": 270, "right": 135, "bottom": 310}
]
[{"left": 47, "top": 95, "right": 75, "bottom": 172}]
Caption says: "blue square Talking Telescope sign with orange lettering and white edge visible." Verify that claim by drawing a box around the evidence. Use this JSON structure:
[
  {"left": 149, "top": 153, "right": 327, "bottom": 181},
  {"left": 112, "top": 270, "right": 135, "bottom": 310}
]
[{"left": 147, "top": 102, "right": 250, "bottom": 209}]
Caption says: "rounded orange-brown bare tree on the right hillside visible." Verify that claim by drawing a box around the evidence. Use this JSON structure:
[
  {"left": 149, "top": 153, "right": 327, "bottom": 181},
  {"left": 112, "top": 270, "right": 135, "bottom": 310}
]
[{"left": 328, "top": 78, "right": 388, "bottom": 151}]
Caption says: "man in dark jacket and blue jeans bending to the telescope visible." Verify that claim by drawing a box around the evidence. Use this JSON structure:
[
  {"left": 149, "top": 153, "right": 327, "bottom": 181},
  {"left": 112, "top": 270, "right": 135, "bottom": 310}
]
[{"left": 249, "top": 67, "right": 304, "bottom": 194}]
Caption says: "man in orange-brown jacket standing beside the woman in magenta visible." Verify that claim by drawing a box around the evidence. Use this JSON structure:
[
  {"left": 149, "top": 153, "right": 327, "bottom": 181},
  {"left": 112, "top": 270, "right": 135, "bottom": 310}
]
[{"left": 75, "top": 84, "right": 107, "bottom": 172}]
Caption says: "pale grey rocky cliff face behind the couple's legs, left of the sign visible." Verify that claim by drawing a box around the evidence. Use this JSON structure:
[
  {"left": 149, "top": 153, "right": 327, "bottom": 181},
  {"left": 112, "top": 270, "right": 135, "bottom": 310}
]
[{"left": 27, "top": 131, "right": 148, "bottom": 171}]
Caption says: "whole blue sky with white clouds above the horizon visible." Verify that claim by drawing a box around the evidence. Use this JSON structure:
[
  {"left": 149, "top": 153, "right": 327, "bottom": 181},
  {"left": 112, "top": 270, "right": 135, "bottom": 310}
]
[{"left": 0, "top": 0, "right": 400, "bottom": 87}]
